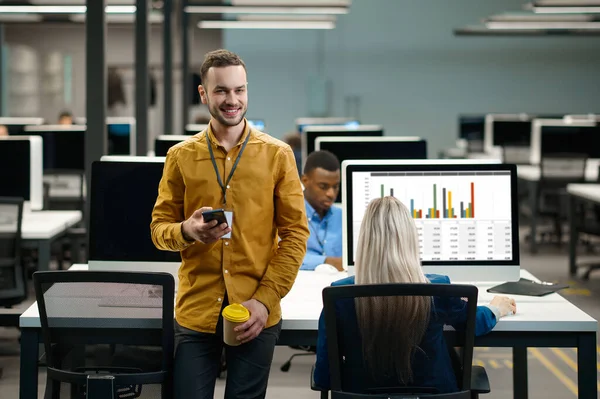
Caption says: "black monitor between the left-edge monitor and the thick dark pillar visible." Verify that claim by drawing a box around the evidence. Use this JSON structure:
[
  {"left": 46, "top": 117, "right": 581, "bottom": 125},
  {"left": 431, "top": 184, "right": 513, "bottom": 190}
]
[{"left": 25, "top": 125, "right": 86, "bottom": 173}]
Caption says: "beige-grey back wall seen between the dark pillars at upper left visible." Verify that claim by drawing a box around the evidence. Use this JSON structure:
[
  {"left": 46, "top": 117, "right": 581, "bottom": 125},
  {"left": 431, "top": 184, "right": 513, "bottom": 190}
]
[{"left": 5, "top": 23, "right": 222, "bottom": 136}]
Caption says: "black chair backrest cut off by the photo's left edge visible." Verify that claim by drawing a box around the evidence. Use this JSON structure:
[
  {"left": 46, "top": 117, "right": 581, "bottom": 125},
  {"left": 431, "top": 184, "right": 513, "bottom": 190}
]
[{"left": 0, "top": 197, "right": 27, "bottom": 306}]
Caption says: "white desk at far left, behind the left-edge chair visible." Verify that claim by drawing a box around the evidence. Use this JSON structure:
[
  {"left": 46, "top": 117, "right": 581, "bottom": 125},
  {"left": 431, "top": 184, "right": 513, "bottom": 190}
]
[{"left": 21, "top": 211, "right": 82, "bottom": 270}]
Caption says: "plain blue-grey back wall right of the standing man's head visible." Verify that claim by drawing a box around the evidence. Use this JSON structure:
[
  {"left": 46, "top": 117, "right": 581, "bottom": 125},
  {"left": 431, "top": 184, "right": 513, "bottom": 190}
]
[{"left": 224, "top": 0, "right": 600, "bottom": 156}]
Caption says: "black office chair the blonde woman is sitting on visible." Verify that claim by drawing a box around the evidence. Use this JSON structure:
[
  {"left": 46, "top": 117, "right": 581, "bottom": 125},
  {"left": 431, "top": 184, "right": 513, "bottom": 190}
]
[{"left": 311, "top": 284, "right": 490, "bottom": 399}]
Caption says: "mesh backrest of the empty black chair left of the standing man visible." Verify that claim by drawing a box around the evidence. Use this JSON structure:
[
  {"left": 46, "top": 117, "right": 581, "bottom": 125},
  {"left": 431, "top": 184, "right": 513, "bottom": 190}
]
[{"left": 33, "top": 271, "right": 175, "bottom": 396}]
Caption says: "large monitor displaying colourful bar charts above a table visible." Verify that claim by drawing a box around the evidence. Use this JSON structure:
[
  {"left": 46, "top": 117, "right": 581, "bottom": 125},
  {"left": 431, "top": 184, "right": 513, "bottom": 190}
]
[{"left": 342, "top": 160, "right": 520, "bottom": 282}]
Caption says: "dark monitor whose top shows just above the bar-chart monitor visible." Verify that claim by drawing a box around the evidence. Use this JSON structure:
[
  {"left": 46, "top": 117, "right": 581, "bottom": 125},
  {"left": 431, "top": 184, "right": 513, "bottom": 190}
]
[{"left": 315, "top": 136, "right": 427, "bottom": 203}]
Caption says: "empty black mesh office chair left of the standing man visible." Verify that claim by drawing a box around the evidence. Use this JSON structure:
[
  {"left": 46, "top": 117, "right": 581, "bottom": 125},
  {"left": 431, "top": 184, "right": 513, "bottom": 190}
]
[{"left": 33, "top": 271, "right": 175, "bottom": 399}]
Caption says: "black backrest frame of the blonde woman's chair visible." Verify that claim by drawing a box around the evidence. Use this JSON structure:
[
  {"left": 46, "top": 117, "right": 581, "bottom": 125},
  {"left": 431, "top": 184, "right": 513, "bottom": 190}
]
[{"left": 323, "top": 284, "right": 477, "bottom": 398}]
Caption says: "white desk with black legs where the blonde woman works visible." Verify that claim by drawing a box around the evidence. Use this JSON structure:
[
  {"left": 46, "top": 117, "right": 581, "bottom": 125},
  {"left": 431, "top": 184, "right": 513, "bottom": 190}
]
[{"left": 20, "top": 265, "right": 597, "bottom": 399}]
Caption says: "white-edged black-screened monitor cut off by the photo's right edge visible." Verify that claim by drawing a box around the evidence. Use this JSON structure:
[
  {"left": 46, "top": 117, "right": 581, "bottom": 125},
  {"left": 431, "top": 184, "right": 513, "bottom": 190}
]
[{"left": 530, "top": 118, "right": 600, "bottom": 165}]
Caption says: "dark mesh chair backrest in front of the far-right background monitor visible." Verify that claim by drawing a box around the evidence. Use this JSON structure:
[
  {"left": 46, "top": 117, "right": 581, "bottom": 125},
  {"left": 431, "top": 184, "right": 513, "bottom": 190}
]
[{"left": 540, "top": 153, "right": 588, "bottom": 183}]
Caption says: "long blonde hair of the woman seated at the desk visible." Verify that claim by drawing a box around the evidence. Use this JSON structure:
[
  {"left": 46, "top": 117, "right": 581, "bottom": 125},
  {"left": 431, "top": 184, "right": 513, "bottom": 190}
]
[{"left": 355, "top": 197, "right": 431, "bottom": 384}]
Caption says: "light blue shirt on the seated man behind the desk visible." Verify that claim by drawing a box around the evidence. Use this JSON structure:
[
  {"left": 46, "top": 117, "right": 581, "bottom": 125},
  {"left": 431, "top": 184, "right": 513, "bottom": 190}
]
[{"left": 300, "top": 200, "right": 342, "bottom": 270}]
